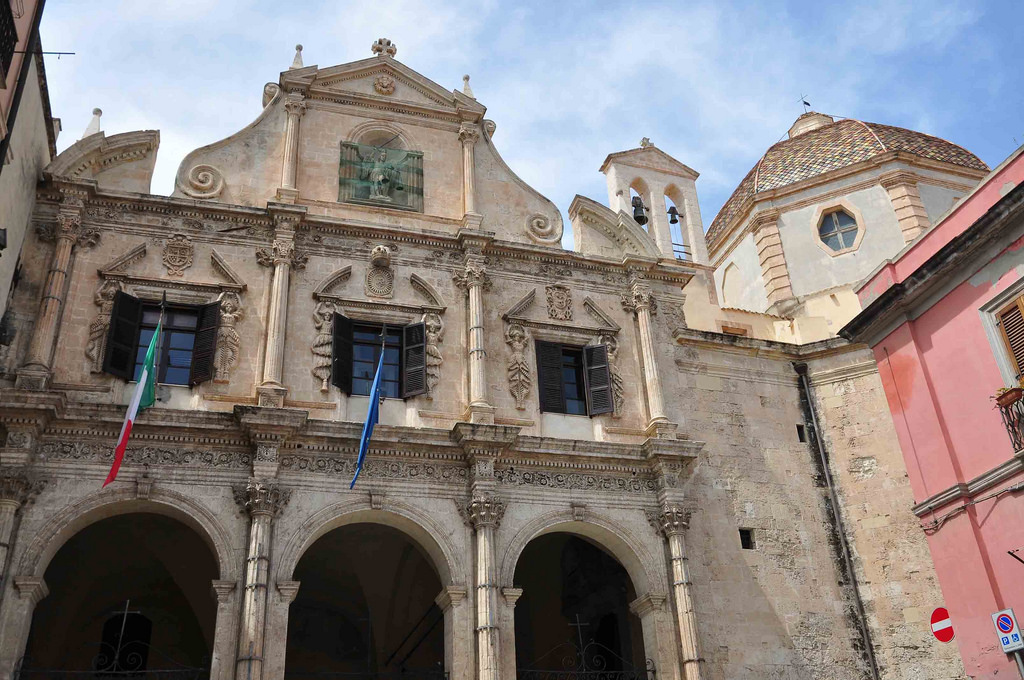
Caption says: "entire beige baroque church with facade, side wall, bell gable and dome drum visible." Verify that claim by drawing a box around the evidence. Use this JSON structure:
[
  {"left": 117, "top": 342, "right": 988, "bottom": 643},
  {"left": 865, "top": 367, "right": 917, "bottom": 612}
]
[{"left": 0, "top": 39, "right": 983, "bottom": 680}]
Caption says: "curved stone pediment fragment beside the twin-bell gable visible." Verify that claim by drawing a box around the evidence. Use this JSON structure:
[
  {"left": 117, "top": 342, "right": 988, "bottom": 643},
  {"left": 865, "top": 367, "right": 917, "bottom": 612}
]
[{"left": 569, "top": 195, "right": 660, "bottom": 258}]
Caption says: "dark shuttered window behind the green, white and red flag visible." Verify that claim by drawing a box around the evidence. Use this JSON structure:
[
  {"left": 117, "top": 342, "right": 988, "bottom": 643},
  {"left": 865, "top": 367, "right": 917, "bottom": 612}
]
[{"left": 103, "top": 293, "right": 220, "bottom": 385}]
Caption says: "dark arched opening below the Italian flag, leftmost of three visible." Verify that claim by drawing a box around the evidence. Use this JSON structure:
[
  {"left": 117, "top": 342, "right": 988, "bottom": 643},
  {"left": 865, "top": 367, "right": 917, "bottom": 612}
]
[{"left": 19, "top": 512, "right": 218, "bottom": 680}]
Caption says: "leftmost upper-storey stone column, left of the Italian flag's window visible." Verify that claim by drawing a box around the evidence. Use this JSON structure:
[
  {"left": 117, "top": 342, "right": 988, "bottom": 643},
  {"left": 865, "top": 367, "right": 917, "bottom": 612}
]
[{"left": 16, "top": 189, "right": 99, "bottom": 390}]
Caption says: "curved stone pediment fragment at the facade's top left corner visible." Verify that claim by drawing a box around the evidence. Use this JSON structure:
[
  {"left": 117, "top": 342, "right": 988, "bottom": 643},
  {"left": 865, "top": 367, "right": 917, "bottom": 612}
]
[{"left": 45, "top": 130, "right": 160, "bottom": 194}]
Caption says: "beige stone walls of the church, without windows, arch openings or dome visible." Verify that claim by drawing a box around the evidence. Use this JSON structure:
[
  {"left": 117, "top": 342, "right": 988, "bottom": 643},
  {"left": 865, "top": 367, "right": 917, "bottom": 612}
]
[{"left": 0, "top": 39, "right": 962, "bottom": 680}]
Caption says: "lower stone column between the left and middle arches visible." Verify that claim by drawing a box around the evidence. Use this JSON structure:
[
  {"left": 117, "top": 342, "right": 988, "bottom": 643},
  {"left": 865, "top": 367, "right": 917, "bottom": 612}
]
[{"left": 234, "top": 478, "right": 289, "bottom": 680}]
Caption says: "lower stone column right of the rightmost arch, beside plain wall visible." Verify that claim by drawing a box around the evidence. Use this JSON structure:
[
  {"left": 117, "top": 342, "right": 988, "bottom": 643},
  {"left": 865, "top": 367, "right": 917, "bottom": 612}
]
[{"left": 657, "top": 505, "right": 701, "bottom": 680}]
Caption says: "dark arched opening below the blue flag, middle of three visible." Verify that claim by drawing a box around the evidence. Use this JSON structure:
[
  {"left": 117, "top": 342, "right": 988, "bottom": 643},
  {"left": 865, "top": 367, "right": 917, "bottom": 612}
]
[{"left": 285, "top": 522, "right": 444, "bottom": 680}]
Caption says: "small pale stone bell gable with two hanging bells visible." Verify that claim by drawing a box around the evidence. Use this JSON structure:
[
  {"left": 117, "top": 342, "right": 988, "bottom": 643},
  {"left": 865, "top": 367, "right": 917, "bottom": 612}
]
[{"left": 601, "top": 137, "right": 708, "bottom": 264}]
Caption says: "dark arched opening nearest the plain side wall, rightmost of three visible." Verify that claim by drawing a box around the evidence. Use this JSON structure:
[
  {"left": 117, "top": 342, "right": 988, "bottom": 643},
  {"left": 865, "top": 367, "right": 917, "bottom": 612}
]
[{"left": 514, "top": 533, "right": 653, "bottom": 680}]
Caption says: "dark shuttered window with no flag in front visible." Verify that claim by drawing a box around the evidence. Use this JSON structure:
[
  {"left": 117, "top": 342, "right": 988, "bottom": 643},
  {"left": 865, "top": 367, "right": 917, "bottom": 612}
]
[{"left": 537, "top": 340, "right": 613, "bottom": 416}]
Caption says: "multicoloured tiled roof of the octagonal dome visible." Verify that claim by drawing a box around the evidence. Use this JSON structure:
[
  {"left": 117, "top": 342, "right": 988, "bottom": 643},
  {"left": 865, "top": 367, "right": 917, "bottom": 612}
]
[{"left": 708, "top": 112, "right": 988, "bottom": 248}]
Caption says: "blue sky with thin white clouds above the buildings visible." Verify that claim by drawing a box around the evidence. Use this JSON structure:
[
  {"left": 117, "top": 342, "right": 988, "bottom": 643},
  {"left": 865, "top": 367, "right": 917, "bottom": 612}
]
[{"left": 41, "top": 0, "right": 1024, "bottom": 249}]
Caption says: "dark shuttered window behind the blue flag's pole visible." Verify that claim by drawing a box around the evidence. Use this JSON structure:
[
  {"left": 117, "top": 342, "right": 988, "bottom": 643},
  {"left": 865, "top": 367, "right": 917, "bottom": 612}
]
[{"left": 331, "top": 312, "right": 427, "bottom": 398}]
